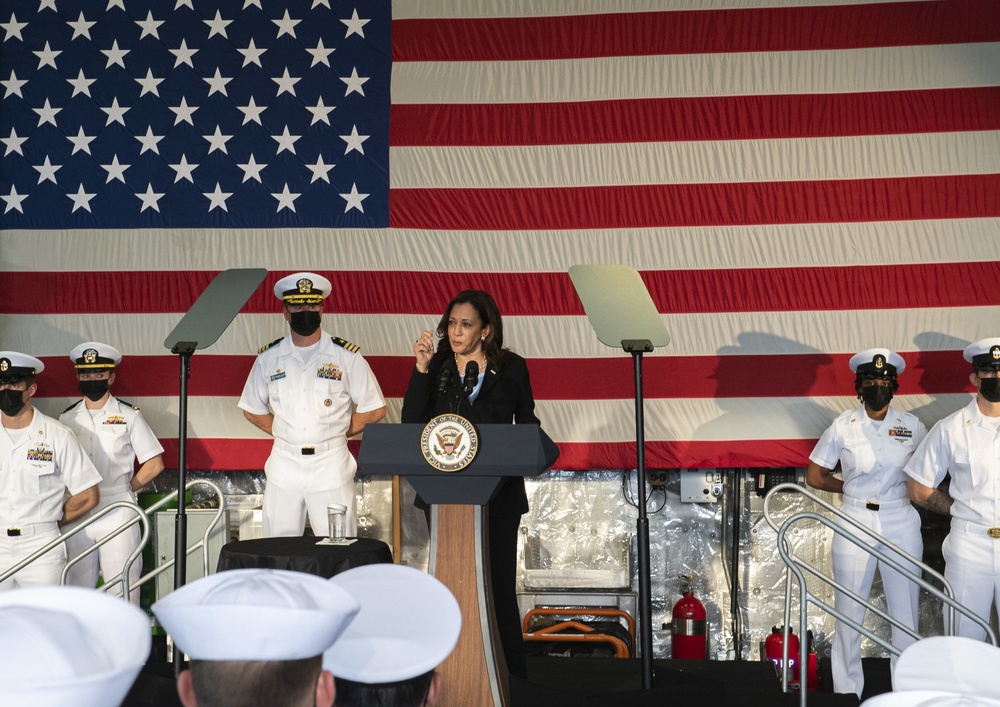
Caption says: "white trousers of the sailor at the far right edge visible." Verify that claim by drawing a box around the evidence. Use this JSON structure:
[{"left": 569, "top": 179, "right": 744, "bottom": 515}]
[{"left": 941, "top": 519, "right": 1000, "bottom": 641}]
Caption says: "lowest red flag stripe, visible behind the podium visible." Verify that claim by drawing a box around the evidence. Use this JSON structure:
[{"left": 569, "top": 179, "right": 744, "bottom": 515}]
[{"left": 160, "top": 436, "right": 816, "bottom": 474}]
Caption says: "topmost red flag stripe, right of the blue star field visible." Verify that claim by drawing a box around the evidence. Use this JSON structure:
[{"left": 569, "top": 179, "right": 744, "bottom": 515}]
[{"left": 392, "top": 0, "right": 1000, "bottom": 62}]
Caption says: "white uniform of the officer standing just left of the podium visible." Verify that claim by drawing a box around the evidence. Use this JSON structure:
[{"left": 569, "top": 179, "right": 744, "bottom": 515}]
[{"left": 239, "top": 333, "right": 385, "bottom": 537}]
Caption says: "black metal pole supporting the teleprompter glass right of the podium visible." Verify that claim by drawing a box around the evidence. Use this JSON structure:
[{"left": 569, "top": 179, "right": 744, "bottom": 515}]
[{"left": 622, "top": 339, "right": 653, "bottom": 690}]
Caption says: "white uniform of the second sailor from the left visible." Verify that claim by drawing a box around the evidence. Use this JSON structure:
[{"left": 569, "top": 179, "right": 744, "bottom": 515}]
[{"left": 59, "top": 395, "right": 163, "bottom": 601}]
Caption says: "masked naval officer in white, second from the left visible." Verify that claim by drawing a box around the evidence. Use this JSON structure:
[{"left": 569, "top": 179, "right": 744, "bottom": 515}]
[{"left": 59, "top": 341, "right": 163, "bottom": 604}]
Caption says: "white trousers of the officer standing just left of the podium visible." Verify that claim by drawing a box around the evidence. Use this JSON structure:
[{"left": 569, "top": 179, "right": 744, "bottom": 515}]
[{"left": 263, "top": 443, "right": 358, "bottom": 537}]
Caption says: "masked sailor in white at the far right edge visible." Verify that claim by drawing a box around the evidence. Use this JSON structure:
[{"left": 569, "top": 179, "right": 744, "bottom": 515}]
[{"left": 906, "top": 337, "right": 1000, "bottom": 641}]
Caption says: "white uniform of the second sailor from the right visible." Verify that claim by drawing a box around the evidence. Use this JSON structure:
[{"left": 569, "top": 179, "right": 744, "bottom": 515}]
[{"left": 809, "top": 405, "right": 927, "bottom": 696}]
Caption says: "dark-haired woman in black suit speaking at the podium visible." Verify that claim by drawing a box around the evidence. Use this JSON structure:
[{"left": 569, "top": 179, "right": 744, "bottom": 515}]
[{"left": 402, "top": 290, "right": 539, "bottom": 678}]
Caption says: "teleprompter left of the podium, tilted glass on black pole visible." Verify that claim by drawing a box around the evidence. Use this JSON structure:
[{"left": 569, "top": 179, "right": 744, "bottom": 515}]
[{"left": 163, "top": 268, "right": 267, "bottom": 670}]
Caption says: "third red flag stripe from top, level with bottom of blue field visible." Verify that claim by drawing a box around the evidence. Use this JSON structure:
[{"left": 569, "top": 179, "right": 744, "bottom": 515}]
[{"left": 389, "top": 174, "right": 1000, "bottom": 231}]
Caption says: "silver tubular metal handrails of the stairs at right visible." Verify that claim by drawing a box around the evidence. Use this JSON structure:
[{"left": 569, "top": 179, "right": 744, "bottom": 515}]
[{"left": 764, "top": 483, "right": 997, "bottom": 707}]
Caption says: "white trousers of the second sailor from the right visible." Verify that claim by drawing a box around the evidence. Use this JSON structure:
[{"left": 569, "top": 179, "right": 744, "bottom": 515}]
[{"left": 830, "top": 499, "right": 924, "bottom": 697}]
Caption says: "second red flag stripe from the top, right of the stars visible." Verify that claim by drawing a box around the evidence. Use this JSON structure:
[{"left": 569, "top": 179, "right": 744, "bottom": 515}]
[{"left": 390, "top": 88, "right": 1000, "bottom": 147}]
